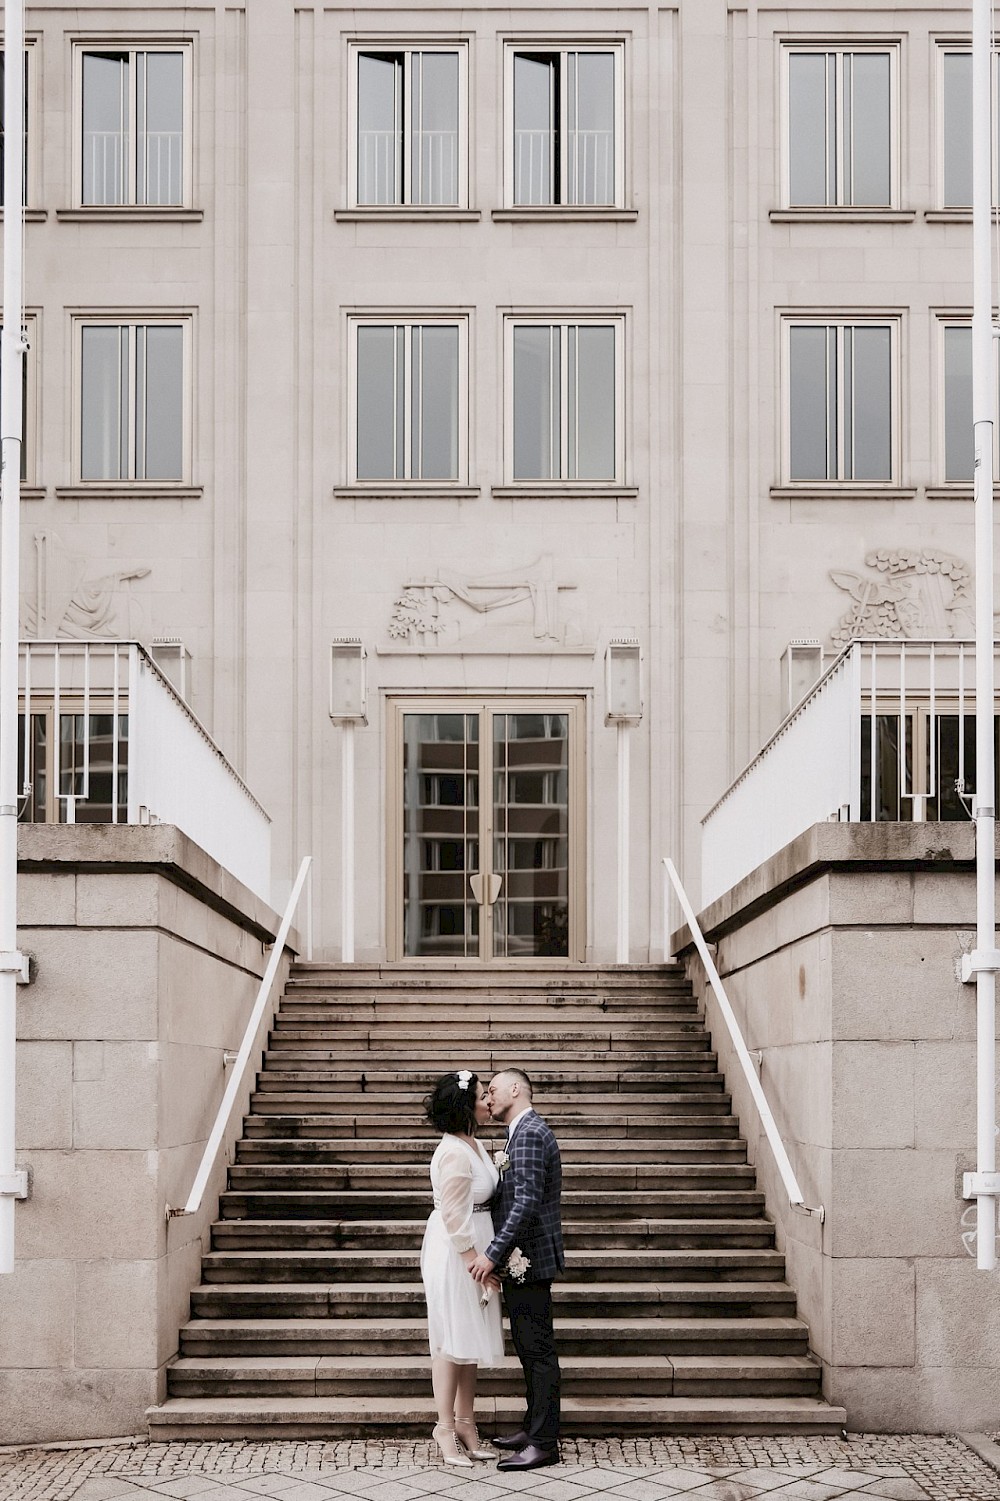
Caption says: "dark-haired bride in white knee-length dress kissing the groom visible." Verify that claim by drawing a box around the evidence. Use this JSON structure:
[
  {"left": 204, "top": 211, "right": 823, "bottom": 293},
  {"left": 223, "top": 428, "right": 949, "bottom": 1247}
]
[{"left": 420, "top": 1069, "right": 503, "bottom": 1466}]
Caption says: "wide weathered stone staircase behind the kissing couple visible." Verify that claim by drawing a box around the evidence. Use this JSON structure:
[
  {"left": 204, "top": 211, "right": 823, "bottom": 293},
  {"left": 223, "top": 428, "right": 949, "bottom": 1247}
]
[{"left": 147, "top": 964, "right": 845, "bottom": 1439}]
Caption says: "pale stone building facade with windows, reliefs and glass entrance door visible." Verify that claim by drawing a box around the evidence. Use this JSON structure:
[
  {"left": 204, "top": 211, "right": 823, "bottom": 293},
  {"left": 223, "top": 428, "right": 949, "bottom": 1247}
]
[{"left": 11, "top": 0, "right": 971, "bottom": 961}]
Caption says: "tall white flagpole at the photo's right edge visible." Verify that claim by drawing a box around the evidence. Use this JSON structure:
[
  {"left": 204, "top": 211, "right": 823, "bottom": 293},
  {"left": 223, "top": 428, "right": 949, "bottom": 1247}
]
[{"left": 973, "top": 0, "right": 997, "bottom": 1271}]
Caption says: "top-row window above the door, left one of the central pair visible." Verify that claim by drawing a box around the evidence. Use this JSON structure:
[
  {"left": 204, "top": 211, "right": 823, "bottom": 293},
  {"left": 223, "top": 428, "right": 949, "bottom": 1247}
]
[{"left": 351, "top": 47, "right": 467, "bottom": 207}]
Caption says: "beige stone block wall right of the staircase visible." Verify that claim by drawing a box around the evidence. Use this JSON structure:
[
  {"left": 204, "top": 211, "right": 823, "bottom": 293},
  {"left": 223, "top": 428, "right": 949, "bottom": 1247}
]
[{"left": 678, "top": 824, "right": 1000, "bottom": 1432}]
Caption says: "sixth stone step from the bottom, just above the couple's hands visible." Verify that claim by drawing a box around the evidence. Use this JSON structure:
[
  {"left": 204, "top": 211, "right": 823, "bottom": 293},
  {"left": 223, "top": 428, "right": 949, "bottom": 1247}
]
[{"left": 212, "top": 1211, "right": 775, "bottom": 1252}]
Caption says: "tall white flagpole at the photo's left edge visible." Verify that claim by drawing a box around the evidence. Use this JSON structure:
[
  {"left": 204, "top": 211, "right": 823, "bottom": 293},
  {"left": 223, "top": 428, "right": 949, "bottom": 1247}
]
[{"left": 0, "top": 0, "right": 26, "bottom": 1273}]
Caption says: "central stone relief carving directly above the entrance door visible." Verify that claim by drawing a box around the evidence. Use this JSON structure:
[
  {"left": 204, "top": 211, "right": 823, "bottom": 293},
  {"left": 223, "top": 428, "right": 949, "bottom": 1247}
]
[{"left": 382, "top": 554, "right": 583, "bottom": 650}]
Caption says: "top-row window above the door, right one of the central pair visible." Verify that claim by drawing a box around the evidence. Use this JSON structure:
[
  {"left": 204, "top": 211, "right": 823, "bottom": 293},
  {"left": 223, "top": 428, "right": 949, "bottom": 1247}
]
[{"left": 508, "top": 45, "right": 623, "bottom": 207}]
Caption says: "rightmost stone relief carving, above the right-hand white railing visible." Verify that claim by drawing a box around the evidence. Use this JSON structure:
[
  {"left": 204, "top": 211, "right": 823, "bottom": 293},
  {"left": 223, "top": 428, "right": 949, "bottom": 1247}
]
[{"left": 829, "top": 548, "right": 974, "bottom": 645}]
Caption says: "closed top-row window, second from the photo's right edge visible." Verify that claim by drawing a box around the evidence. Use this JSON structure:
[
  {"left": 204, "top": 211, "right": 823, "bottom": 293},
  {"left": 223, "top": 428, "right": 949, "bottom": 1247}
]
[{"left": 785, "top": 47, "right": 896, "bottom": 209}]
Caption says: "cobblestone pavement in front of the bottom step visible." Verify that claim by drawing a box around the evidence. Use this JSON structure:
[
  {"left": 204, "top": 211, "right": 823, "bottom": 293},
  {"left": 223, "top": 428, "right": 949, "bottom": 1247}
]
[{"left": 0, "top": 1433, "right": 1000, "bottom": 1501}]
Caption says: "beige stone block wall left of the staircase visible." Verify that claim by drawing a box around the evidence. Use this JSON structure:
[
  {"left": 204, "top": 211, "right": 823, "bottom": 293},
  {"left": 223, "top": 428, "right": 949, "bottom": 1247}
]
[{"left": 0, "top": 827, "right": 282, "bottom": 1442}]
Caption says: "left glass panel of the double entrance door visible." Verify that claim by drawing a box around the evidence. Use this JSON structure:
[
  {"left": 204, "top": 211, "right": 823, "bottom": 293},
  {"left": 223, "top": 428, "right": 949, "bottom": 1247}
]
[{"left": 402, "top": 714, "right": 479, "bottom": 958}]
